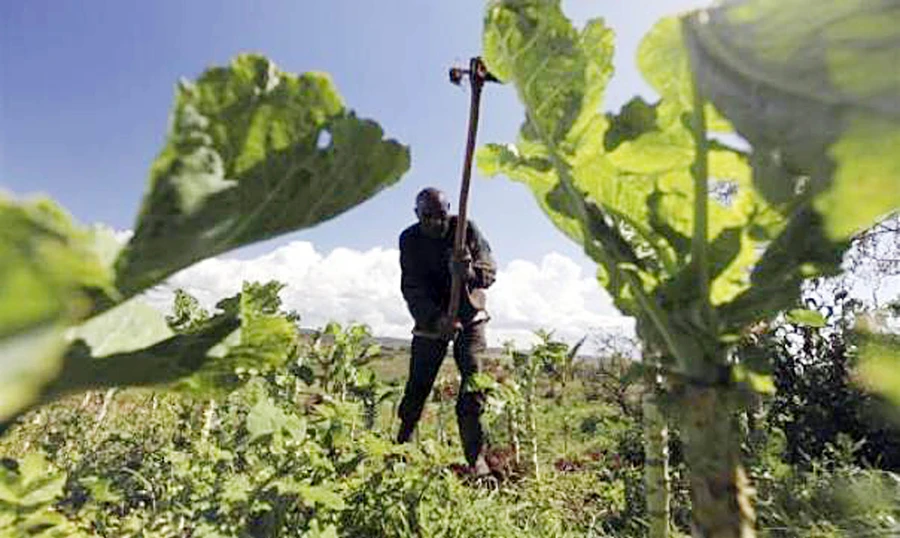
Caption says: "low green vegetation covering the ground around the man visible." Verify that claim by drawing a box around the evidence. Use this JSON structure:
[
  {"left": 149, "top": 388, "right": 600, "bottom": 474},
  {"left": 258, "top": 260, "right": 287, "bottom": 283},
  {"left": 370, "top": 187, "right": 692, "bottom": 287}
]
[{"left": 0, "top": 283, "right": 900, "bottom": 538}]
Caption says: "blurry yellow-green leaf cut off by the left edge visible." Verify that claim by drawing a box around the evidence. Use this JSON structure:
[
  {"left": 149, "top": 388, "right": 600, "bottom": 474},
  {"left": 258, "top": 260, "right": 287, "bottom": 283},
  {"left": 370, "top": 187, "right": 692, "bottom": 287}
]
[{"left": 0, "top": 194, "right": 114, "bottom": 421}]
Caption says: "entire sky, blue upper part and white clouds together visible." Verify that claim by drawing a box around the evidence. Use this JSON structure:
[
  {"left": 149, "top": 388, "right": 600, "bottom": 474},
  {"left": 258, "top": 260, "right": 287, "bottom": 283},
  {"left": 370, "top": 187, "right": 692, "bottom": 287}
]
[{"left": 0, "top": 0, "right": 744, "bottom": 350}]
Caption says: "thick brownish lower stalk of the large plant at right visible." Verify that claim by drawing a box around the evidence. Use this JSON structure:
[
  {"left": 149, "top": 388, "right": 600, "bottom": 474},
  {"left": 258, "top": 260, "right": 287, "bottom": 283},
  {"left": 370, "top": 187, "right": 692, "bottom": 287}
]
[{"left": 682, "top": 387, "right": 756, "bottom": 538}]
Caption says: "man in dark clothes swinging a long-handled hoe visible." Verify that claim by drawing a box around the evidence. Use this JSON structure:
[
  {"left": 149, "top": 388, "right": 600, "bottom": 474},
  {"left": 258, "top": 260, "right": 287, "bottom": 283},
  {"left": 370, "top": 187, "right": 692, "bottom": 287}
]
[{"left": 397, "top": 188, "right": 497, "bottom": 475}]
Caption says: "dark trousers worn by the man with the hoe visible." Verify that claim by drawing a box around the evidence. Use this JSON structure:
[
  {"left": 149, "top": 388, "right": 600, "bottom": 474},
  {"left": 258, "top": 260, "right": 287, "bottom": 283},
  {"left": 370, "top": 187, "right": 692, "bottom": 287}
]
[{"left": 397, "top": 322, "right": 487, "bottom": 465}]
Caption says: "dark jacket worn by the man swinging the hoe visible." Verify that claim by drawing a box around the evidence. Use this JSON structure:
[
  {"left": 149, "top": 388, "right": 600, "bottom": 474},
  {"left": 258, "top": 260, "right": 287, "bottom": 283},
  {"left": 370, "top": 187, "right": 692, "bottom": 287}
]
[{"left": 400, "top": 216, "right": 497, "bottom": 331}]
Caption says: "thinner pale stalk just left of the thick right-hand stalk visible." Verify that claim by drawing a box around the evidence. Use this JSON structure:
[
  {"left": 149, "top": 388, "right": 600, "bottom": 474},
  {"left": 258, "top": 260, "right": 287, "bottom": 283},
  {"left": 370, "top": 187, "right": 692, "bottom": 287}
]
[{"left": 641, "top": 374, "right": 670, "bottom": 538}]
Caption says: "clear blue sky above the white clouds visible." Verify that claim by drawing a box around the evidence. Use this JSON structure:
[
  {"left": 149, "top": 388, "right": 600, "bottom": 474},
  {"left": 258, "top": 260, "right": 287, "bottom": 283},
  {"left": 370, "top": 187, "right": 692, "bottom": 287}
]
[{"left": 0, "top": 0, "right": 696, "bottom": 269}]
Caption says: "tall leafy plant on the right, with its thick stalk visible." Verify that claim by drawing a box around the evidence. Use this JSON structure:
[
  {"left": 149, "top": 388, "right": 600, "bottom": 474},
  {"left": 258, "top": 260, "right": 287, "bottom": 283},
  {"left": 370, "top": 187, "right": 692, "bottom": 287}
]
[{"left": 479, "top": 0, "right": 900, "bottom": 536}]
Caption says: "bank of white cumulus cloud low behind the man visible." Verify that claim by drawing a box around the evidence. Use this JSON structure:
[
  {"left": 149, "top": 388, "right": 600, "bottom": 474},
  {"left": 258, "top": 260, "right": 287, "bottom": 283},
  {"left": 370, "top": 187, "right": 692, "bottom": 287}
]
[{"left": 145, "top": 241, "right": 631, "bottom": 347}]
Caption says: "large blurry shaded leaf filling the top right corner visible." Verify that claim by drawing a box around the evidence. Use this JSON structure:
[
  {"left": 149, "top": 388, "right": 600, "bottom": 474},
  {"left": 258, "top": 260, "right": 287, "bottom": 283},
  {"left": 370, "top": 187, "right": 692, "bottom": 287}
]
[{"left": 684, "top": 0, "right": 900, "bottom": 240}]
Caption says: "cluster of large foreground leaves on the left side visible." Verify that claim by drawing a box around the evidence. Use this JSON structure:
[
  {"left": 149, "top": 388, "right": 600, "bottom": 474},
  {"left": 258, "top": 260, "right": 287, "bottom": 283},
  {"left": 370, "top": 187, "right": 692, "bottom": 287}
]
[{"left": 0, "top": 55, "right": 409, "bottom": 424}]
